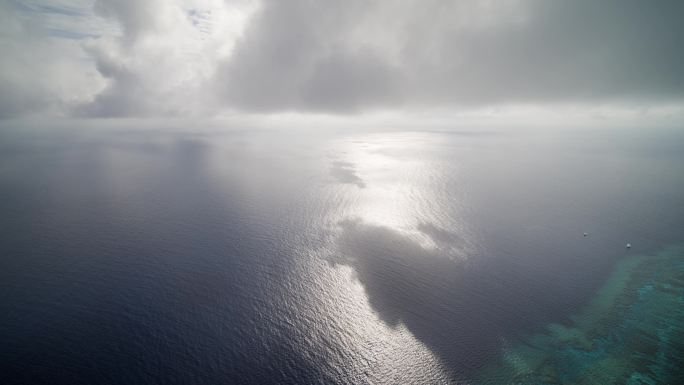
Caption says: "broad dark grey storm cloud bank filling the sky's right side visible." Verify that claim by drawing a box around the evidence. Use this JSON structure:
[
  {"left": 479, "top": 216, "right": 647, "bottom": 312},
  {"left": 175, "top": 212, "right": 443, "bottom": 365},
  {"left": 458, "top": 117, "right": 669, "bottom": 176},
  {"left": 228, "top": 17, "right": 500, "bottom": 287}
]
[{"left": 217, "top": 0, "right": 684, "bottom": 112}]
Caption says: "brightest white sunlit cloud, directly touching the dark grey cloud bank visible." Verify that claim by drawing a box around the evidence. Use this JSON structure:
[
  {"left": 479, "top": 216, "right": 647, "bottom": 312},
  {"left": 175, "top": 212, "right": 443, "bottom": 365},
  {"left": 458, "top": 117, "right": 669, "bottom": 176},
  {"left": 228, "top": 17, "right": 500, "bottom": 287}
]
[{"left": 79, "top": 0, "right": 256, "bottom": 117}]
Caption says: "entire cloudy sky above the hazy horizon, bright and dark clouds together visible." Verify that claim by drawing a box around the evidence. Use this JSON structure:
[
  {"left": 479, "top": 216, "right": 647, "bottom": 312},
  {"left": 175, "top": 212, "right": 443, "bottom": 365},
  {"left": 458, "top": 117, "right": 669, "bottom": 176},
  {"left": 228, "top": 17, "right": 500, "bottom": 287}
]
[{"left": 0, "top": 0, "right": 684, "bottom": 118}]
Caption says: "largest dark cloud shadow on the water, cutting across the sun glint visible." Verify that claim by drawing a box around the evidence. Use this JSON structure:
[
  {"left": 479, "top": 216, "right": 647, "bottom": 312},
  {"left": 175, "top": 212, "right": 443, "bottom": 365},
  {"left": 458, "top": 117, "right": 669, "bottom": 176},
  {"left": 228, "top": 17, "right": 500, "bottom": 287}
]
[{"left": 333, "top": 220, "right": 540, "bottom": 377}]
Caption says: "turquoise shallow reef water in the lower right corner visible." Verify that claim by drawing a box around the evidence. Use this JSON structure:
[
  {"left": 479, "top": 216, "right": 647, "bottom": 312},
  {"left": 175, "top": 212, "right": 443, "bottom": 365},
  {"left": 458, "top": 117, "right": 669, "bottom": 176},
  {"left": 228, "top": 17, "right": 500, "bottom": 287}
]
[{"left": 481, "top": 245, "right": 684, "bottom": 384}]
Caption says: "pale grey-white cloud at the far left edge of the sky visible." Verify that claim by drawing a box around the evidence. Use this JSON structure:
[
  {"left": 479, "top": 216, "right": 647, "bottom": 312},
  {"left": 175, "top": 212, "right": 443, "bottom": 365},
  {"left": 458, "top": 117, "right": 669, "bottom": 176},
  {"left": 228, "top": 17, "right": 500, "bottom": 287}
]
[{"left": 0, "top": 1, "right": 104, "bottom": 119}]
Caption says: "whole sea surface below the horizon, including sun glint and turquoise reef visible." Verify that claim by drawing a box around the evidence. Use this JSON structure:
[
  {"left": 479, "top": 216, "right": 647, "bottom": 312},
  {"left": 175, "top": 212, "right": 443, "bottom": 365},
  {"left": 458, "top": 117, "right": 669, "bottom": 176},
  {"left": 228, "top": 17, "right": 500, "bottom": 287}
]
[{"left": 0, "top": 121, "right": 684, "bottom": 384}]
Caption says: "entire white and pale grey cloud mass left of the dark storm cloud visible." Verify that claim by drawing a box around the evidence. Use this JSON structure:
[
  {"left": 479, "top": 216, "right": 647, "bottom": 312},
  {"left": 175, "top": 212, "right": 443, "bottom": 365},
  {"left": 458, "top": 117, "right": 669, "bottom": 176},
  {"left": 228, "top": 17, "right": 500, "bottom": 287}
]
[{"left": 0, "top": 0, "right": 255, "bottom": 118}]
